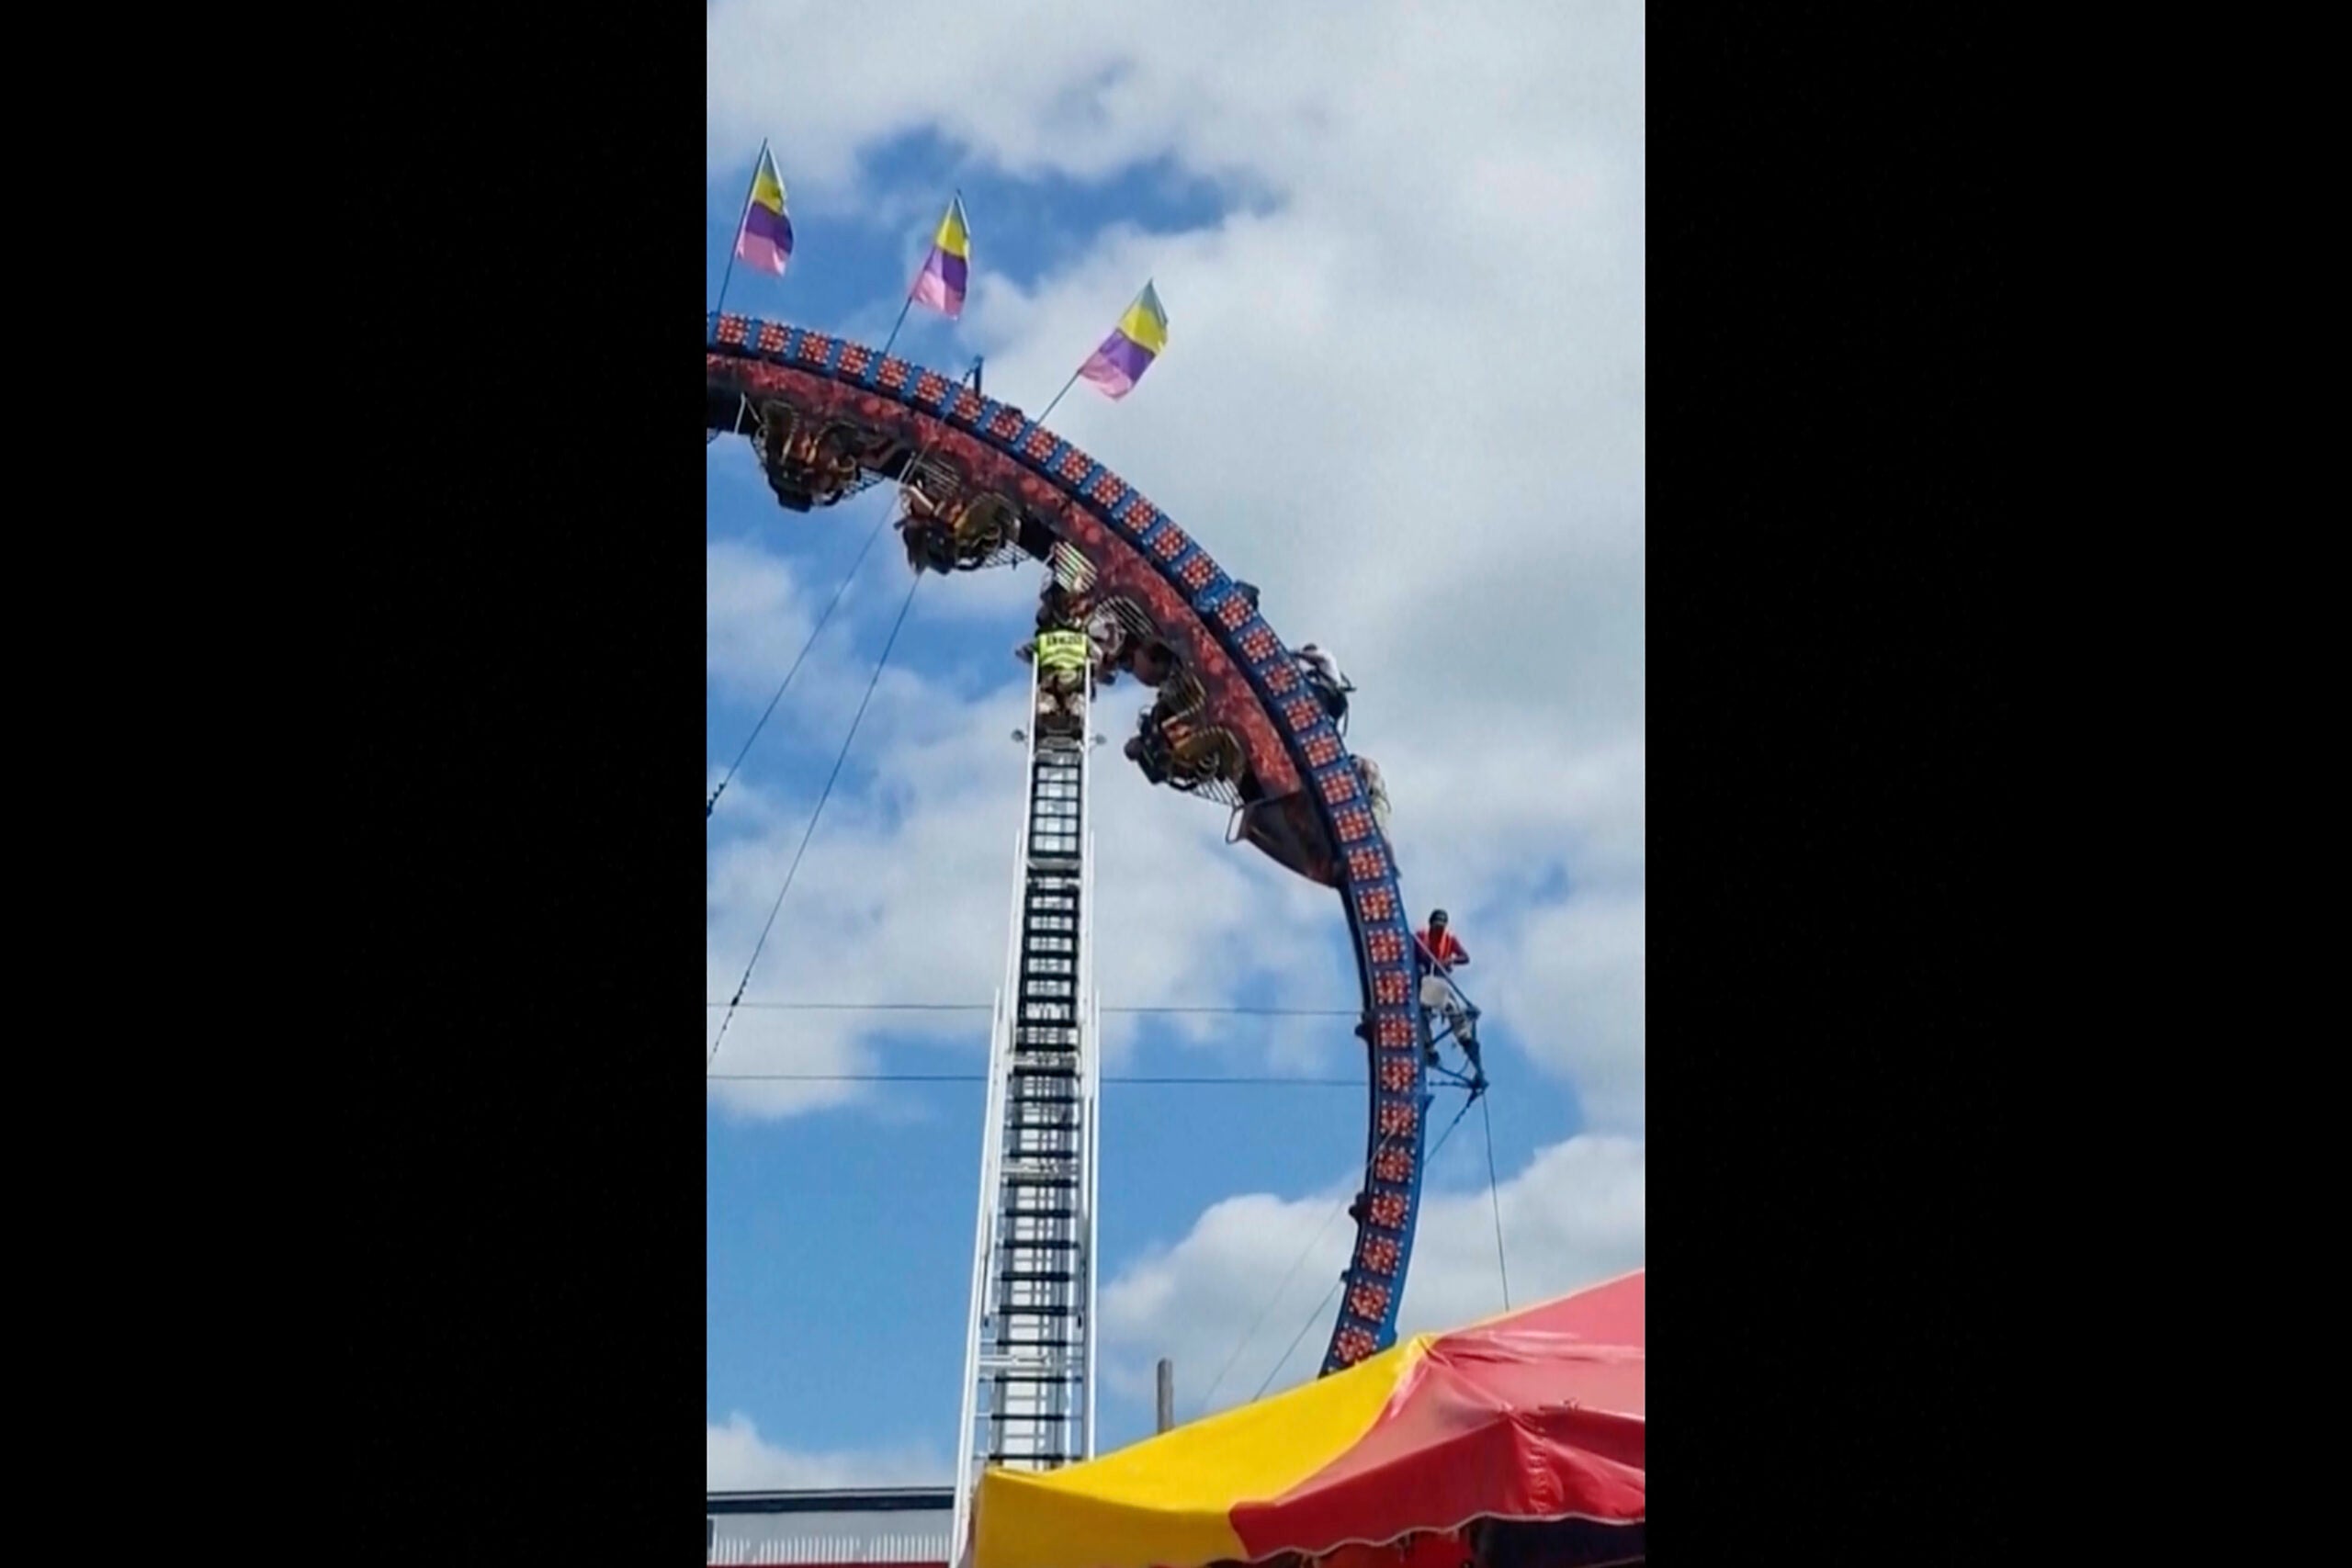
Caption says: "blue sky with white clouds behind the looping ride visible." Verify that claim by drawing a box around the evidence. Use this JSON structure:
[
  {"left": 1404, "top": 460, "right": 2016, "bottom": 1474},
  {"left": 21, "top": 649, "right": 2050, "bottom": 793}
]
[{"left": 703, "top": 0, "right": 1646, "bottom": 1488}]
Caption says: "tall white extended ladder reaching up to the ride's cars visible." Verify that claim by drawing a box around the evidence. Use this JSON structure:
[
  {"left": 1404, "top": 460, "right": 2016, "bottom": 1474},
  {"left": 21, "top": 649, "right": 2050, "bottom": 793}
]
[{"left": 950, "top": 649, "right": 1101, "bottom": 1554}]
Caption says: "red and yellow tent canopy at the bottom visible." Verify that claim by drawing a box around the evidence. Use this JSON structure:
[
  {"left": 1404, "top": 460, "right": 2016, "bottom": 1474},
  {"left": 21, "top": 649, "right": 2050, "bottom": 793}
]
[{"left": 971, "top": 1272, "right": 1644, "bottom": 1568}]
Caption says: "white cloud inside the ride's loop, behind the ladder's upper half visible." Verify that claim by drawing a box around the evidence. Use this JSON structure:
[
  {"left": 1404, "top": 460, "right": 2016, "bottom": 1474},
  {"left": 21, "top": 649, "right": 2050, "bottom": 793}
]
[{"left": 703, "top": 547, "right": 1355, "bottom": 1117}]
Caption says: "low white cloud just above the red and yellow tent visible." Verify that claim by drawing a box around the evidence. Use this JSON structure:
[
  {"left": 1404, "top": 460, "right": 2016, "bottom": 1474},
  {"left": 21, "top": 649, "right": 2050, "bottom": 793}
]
[{"left": 1101, "top": 1133, "right": 1646, "bottom": 1420}]
